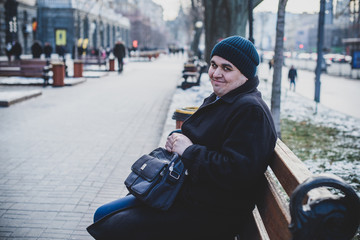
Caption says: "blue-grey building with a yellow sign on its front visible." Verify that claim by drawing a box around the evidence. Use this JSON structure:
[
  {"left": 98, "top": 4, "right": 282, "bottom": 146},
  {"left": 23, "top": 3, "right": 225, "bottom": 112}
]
[{"left": 36, "top": 0, "right": 130, "bottom": 56}]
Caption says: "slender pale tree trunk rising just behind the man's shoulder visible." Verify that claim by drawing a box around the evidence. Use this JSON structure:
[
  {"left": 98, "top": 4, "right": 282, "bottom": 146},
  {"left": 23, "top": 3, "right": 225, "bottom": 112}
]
[{"left": 271, "top": 0, "right": 287, "bottom": 138}]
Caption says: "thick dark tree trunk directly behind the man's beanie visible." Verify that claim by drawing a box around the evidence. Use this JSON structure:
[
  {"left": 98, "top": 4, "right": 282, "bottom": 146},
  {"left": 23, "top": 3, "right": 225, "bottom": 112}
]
[{"left": 203, "top": 0, "right": 262, "bottom": 62}]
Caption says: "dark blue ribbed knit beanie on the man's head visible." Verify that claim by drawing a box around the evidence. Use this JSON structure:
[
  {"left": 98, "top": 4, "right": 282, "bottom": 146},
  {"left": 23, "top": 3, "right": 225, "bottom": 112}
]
[{"left": 210, "top": 36, "right": 260, "bottom": 79}]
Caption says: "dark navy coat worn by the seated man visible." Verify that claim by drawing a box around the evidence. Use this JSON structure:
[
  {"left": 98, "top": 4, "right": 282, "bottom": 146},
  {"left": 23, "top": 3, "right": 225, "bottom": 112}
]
[{"left": 180, "top": 77, "right": 277, "bottom": 213}]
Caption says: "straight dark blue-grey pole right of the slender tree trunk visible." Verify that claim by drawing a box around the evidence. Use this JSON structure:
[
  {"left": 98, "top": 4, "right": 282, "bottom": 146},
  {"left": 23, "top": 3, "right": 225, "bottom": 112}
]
[{"left": 314, "top": 0, "right": 325, "bottom": 114}]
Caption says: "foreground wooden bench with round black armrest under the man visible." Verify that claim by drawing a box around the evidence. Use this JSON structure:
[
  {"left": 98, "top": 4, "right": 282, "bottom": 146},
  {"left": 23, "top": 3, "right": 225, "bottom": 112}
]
[{"left": 235, "top": 140, "right": 360, "bottom": 240}]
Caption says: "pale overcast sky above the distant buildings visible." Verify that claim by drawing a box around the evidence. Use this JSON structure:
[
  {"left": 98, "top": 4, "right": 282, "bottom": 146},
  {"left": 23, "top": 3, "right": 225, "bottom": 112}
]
[{"left": 153, "top": 0, "right": 320, "bottom": 20}]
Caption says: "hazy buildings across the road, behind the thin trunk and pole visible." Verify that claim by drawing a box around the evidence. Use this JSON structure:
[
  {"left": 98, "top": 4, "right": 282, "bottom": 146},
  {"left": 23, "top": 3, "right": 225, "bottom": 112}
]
[{"left": 254, "top": 0, "right": 360, "bottom": 55}]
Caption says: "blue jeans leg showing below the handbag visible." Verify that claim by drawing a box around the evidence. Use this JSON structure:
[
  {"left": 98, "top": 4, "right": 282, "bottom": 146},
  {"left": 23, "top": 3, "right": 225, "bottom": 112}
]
[{"left": 94, "top": 195, "right": 142, "bottom": 222}]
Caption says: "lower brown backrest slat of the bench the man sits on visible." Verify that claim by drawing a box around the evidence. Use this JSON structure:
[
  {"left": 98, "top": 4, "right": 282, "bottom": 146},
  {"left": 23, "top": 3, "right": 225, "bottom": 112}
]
[{"left": 257, "top": 172, "right": 291, "bottom": 240}]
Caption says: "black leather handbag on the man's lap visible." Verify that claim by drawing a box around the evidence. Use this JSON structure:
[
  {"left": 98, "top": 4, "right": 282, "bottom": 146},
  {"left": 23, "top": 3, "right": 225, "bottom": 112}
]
[{"left": 125, "top": 147, "right": 187, "bottom": 210}]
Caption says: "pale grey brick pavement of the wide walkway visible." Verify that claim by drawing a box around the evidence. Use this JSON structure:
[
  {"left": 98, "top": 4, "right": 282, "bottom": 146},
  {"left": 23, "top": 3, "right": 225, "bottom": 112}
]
[{"left": 0, "top": 53, "right": 185, "bottom": 240}]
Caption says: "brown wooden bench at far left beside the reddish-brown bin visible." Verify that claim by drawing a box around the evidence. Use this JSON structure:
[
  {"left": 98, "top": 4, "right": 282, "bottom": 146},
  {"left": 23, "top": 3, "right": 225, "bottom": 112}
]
[{"left": 0, "top": 59, "right": 51, "bottom": 85}]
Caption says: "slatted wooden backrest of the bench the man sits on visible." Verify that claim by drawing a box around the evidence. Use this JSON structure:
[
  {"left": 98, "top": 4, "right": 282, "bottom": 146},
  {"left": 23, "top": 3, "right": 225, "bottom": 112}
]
[{"left": 241, "top": 140, "right": 326, "bottom": 240}]
